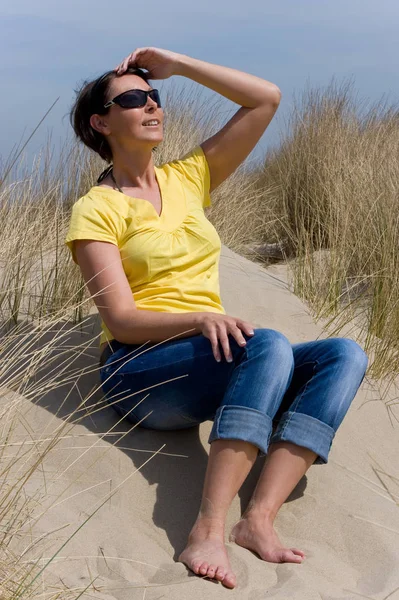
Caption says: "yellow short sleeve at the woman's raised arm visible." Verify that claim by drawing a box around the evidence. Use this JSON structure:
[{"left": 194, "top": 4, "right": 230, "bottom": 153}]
[{"left": 170, "top": 145, "right": 211, "bottom": 207}]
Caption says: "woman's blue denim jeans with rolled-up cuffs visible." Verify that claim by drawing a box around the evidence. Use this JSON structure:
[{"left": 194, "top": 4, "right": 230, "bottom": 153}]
[{"left": 100, "top": 328, "right": 368, "bottom": 464}]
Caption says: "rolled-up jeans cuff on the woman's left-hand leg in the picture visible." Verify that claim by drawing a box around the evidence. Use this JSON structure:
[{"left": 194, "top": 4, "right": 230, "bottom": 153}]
[{"left": 208, "top": 404, "right": 273, "bottom": 454}]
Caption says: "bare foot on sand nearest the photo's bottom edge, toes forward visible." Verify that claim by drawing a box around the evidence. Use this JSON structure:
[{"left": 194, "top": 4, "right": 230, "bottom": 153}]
[{"left": 178, "top": 519, "right": 236, "bottom": 588}]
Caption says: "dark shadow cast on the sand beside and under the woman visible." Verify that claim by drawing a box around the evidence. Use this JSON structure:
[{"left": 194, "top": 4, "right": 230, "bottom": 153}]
[{"left": 14, "top": 322, "right": 306, "bottom": 560}]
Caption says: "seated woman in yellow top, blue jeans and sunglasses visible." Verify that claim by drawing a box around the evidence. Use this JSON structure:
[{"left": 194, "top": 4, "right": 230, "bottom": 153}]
[{"left": 66, "top": 48, "right": 368, "bottom": 588}]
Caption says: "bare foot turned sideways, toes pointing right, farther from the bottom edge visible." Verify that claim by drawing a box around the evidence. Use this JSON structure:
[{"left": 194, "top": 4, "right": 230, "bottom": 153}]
[{"left": 230, "top": 517, "right": 305, "bottom": 563}]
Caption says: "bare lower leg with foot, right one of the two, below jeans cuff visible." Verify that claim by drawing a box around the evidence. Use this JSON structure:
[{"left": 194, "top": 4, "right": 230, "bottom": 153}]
[{"left": 230, "top": 442, "right": 317, "bottom": 563}]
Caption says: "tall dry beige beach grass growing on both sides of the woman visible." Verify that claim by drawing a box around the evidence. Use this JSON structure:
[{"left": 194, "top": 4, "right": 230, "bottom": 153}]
[{"left": 0, "top": 74, "right": 399, "bottom": 600}]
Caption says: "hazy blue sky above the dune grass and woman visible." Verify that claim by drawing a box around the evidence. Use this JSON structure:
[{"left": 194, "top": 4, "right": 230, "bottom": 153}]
[{"left": 0, "top": 0, "right": 399, "bottom": 171}]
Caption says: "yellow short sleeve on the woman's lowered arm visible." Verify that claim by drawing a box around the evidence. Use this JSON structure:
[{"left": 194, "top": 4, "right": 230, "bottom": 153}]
[{"left": 65, "top": 196, "right": 118, "bottom": 264}]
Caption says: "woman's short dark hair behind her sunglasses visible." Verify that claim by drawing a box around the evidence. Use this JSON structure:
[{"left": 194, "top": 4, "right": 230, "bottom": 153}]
[{"left": 70, "top": 66, "right": 149, "bottom": 163}]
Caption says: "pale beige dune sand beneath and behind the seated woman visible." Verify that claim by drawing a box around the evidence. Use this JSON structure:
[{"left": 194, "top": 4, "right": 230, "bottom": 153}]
[{"left": 2, "top": 246, "right": 399, "bottom": 600}]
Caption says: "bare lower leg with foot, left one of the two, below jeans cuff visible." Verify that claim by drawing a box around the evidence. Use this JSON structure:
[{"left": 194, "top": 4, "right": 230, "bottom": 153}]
[{"left": 179, "top": 440, "right": 258, "bottom": 588}]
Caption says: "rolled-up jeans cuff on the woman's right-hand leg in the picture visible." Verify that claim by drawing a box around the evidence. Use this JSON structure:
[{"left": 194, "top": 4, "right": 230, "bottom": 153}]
[{"left": 270, "top": 411, "right": 335, "bottom": 464}]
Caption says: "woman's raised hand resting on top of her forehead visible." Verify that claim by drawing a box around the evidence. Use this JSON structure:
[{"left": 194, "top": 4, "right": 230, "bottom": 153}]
[{"left": 114, "top": 47, "right": 182, "bottom": 79}]
